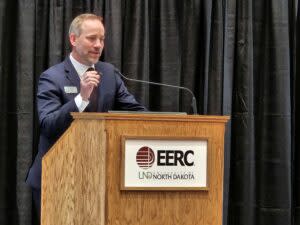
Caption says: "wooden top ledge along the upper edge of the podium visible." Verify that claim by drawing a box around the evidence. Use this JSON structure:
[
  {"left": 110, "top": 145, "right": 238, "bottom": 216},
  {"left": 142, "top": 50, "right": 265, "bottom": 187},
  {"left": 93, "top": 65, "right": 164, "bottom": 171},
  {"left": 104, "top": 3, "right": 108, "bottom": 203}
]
[{"left": 71, "top": 112, "right": 230, "bottom": 123}]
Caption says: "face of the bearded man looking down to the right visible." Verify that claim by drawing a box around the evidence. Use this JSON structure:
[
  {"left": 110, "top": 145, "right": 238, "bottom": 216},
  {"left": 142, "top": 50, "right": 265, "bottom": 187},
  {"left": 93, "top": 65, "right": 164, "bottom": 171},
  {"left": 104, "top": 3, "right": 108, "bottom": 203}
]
[{"left": 70, "top": 20, "right": 105, "bottom": 65}]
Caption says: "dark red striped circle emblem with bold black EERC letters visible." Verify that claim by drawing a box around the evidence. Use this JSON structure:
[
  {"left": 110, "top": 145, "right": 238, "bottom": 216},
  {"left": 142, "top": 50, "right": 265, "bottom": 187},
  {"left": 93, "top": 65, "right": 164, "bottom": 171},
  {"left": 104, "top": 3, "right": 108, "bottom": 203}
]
[{"left": 136, "top": 146, "right": 194, "bottom": 169}]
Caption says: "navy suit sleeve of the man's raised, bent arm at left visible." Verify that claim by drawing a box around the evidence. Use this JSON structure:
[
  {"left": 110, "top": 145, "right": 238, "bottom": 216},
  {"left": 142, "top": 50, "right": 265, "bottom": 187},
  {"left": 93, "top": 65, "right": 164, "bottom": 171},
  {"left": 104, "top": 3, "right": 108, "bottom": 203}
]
[{"left": 37, "top": 73, "right": 78, "bottom": 137}]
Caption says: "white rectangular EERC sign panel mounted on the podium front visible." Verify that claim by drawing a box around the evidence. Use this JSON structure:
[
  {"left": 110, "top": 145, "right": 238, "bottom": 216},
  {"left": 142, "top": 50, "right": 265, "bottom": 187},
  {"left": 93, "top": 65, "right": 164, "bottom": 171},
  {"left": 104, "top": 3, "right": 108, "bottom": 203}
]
[{"left": 123, "top": 139, "right": 207, "bottom": 190}]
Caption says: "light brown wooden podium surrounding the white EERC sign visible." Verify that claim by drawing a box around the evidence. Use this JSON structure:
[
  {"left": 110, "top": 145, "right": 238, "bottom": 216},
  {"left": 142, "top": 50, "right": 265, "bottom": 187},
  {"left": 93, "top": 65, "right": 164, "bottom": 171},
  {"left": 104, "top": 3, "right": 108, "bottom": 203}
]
[{"left": 41, "top": 113, "right": 229, "bottom": 225}]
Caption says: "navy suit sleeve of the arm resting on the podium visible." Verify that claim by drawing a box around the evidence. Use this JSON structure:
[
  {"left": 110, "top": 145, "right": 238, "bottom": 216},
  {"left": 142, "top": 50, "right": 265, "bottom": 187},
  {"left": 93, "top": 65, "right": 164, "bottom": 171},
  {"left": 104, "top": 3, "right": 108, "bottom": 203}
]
[{"left": 115, "top": 71, "right": 147, "bottom": 111}]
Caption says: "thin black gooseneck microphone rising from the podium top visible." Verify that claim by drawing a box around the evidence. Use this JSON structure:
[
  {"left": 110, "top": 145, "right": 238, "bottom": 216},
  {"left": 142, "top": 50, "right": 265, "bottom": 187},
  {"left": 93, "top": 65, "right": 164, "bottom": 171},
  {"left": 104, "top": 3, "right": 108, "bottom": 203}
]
[{"left": 115, "top": 68, "right": 197, "bottom": 115}]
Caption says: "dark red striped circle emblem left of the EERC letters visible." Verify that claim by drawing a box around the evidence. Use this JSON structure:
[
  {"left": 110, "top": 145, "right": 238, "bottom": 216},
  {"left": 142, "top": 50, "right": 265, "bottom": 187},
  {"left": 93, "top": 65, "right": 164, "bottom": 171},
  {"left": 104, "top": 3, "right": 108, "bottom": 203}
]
[{"left": 136, "top": 146, "right": 155, "bottom": 169}]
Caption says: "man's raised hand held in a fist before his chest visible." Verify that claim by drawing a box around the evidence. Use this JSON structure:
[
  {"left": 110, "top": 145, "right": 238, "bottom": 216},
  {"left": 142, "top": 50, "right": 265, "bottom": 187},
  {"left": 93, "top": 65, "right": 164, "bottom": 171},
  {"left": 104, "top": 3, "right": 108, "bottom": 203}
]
[{"left": 80, "top": 70, "right": 100, "bottom": 101}]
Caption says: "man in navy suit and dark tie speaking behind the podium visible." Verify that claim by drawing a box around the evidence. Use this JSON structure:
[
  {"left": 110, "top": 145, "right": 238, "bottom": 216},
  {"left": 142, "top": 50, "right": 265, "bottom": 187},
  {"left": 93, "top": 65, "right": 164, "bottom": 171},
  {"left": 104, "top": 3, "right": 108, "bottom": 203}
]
[{"left": 26, "top": 14, "right": 146, "bottom": 221}]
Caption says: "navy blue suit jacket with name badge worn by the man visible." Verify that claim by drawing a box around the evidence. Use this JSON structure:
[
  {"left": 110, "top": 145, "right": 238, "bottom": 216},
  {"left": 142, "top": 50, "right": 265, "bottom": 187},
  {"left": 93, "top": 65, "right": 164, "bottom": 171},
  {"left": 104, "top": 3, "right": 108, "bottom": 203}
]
[{"left": 26, "top": 57, "right": 146, "bottom": 189}]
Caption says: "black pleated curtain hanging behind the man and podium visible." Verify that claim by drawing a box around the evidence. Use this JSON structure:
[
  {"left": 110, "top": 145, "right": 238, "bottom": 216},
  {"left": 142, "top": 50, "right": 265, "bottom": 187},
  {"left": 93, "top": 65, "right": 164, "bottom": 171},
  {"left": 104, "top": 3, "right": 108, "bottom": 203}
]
[{"left": 0, "top": 0, "right": 300, "bottom": 225}]
